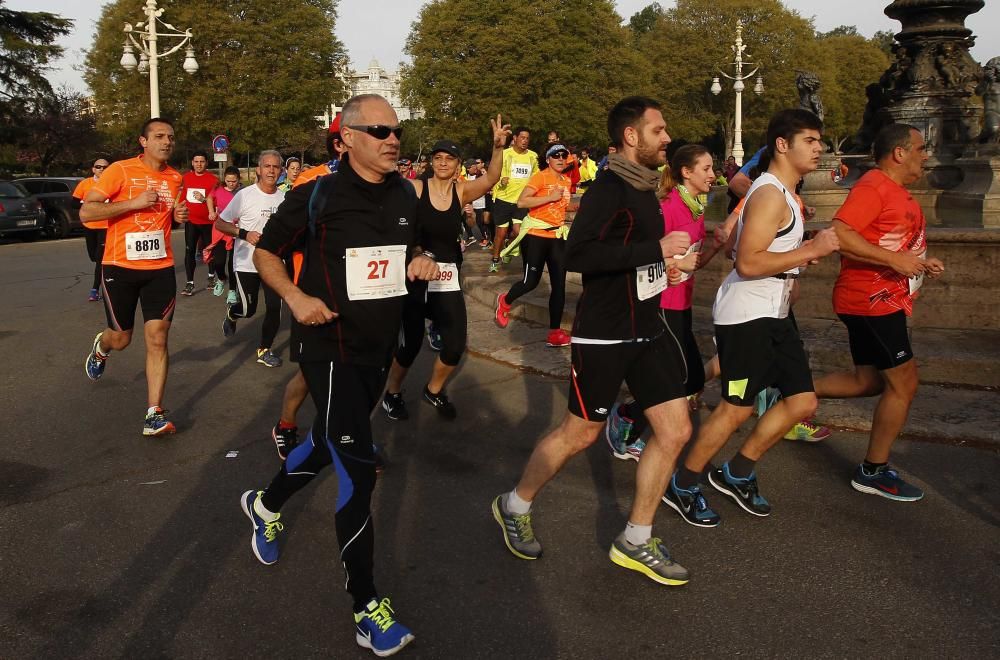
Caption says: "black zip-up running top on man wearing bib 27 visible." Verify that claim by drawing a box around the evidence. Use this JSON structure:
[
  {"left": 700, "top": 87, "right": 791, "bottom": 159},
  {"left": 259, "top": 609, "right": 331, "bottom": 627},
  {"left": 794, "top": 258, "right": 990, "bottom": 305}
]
[{"left": 257, "top": 156, "right": 417, "bottom": 367}]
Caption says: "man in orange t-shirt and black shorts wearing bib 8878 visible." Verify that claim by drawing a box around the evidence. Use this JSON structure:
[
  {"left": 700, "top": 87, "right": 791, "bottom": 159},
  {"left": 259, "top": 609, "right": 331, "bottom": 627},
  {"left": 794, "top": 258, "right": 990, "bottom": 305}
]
[{"left": 80, "top": 118, "right": 188, "bottom": 436}]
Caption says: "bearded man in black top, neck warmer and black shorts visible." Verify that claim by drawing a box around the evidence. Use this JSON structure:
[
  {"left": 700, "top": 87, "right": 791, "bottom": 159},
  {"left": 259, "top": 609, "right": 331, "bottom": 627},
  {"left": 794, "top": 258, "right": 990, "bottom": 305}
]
[{"left": 492, "top": 97, "right": 691, "bottom": 585}]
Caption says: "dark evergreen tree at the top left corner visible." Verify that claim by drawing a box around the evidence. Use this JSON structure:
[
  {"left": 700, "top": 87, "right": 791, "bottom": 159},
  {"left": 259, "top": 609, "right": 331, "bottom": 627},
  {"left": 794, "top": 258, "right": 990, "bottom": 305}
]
[{"left": 0, "top": 0, "right": 73, "bottom": 143}]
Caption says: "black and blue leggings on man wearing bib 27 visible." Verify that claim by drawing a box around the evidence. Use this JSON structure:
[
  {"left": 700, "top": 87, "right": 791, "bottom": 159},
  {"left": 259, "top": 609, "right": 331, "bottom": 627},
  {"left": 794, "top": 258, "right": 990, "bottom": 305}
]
[{"left": 261, "top": 362, "right": 388, "bottom": 612}]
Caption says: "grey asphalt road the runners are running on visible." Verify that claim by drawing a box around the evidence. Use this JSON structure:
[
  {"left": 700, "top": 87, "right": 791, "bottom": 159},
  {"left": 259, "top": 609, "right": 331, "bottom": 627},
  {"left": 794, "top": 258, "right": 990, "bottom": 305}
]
[{"left": 0, "top": 239, "right": 1000, "bottom": 658}]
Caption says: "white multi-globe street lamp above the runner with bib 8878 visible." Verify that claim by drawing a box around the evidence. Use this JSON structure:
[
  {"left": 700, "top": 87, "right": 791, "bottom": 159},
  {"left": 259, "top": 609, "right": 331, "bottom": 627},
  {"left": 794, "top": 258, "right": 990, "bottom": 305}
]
[{"left": 120, "top": 0, "right": 198, "bottom": 117}]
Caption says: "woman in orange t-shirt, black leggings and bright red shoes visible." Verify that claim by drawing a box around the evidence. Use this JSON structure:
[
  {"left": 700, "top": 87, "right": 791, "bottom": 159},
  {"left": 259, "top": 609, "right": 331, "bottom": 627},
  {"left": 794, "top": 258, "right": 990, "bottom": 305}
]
[{"left": 495, "top": 144, "right": 577, "bottom": 347}]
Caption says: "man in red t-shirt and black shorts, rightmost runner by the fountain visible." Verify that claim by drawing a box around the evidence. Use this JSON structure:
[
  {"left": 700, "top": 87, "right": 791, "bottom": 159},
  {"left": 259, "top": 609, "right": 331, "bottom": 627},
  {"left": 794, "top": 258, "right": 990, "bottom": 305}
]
[{"left": 815, "top": 124, "right": 944, "bottom": 502}]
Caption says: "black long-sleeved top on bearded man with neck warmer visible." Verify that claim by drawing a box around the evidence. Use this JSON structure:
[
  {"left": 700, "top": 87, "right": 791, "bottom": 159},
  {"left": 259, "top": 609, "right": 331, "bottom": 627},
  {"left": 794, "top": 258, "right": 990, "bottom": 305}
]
[{"left": 566, "top": 170, "right": 664, "bottom": 341}]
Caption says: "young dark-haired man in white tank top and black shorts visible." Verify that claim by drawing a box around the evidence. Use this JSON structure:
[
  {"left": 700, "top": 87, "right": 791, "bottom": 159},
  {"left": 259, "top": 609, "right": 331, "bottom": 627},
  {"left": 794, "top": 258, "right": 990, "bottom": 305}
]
[{"left": 675, "top": 110, "right": 839, "bottom": 516}]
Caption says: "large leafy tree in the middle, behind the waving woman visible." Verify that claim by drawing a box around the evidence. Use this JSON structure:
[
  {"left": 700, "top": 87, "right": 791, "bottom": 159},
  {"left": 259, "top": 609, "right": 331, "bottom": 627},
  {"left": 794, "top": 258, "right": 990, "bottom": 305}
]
[{"left": 401, "top": 0, "right": 645, "bottom": 155}]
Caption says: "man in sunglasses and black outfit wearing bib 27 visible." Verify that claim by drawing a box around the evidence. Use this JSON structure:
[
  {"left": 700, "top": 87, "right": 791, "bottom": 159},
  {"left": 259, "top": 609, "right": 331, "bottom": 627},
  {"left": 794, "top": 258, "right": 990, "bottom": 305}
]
[{"left": 240, "top": 94, "right": 439, "bottom": 656}]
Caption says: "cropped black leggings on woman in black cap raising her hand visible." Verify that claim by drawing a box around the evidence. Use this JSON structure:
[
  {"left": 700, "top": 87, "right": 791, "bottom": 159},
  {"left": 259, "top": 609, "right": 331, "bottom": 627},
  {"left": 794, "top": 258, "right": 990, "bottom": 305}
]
[{"left": 396, "top": 281, "right": 468, "bottom": 369}]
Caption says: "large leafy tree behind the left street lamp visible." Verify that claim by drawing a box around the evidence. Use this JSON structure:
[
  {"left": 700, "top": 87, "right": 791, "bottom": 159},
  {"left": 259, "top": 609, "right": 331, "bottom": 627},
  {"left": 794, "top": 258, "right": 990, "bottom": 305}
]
[{"left": 84, "top": 0, "right": 347, "bottom": 161}]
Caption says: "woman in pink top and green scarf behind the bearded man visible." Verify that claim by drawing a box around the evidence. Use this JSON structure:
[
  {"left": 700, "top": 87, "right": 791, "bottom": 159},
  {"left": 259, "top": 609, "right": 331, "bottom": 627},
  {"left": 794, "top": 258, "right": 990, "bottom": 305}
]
[{"left": 604, "top": 144, "right": 718, "bottom": 470}]
